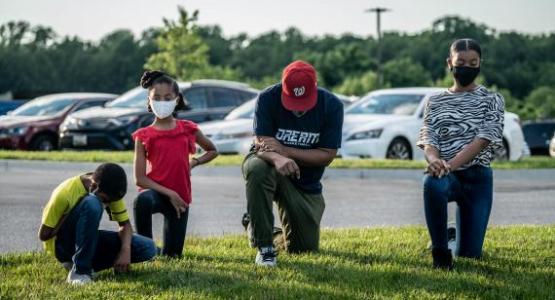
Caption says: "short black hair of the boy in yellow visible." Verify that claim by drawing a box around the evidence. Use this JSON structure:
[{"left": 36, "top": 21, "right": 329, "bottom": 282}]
[{"left": 92, "top": 163, "right": 127, "bottom": 201}]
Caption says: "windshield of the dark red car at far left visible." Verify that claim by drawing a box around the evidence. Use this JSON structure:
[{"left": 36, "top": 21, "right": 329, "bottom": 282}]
[{"left": 11, "top": 97, "right": 75, "bottom": 116}]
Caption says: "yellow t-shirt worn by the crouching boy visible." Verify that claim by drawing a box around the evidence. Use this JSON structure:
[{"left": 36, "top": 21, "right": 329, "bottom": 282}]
[{"left": 42, "top": 175, "right": 129, "bottom": 255}]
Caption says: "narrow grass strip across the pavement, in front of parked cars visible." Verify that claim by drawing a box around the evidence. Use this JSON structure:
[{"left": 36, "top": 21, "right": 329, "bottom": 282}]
[{"left": 0, "top": 150, "right": 555, "bottom": 169}]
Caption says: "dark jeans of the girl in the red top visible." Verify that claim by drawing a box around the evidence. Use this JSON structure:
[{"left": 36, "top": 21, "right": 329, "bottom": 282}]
[{"left": 133, "top": 190, "right": 189, "bottom": 257}]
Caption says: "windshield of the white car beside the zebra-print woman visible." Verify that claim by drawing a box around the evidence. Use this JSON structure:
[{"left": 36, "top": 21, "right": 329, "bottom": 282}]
[{"left": 346, "top": 94, "right": 424, "bottom": 116}]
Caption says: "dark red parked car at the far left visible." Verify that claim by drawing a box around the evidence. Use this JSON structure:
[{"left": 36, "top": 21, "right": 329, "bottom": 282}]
[{"left": 0, "top": 93, "right": 117, "bottom": 151}]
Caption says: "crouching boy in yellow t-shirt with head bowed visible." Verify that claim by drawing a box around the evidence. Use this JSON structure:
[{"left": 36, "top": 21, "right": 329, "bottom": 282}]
[{"left": 39, "top": 163, "right": 157, "bottom": 284}]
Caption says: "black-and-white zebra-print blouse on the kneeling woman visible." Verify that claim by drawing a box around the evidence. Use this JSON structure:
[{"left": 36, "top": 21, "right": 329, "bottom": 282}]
[{"left": 416, "top": 85, "right": 505, "bottom": 169}]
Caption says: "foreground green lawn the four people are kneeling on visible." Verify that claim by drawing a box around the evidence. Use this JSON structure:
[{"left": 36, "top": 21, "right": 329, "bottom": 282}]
[{"left": 0, "top": 225, "right": 555, "bottom": 299}]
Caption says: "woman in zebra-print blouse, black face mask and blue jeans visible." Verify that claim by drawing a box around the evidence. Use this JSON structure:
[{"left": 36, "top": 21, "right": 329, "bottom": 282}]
[{"left": 417, "top": 39, "right": 504, "bottom": 269}]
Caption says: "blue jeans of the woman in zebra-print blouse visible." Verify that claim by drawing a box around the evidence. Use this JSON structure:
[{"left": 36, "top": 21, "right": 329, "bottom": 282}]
[{"left": 424, "top": 166, "right": 493, "bottom": 258}]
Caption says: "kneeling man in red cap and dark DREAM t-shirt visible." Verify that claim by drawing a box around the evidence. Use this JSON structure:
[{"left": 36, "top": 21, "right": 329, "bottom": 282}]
[{"left": 243, "top": 61, "right": 343, "bottom": 266}]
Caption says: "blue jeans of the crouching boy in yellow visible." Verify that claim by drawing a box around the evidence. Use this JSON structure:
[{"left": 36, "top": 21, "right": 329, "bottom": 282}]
[{"left": 56, "top": 195, "right": 156, "bottom": 275}]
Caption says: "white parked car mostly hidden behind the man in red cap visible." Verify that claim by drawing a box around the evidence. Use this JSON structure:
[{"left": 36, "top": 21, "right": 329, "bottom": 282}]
[{"left": 200, "top": 94, "right": 358, "bottom": 154}]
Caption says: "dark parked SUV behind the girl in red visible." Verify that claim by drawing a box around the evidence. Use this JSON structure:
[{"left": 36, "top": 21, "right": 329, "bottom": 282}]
[{"left": 60, "top": 80, "right": 258, "bottom": 150}]
